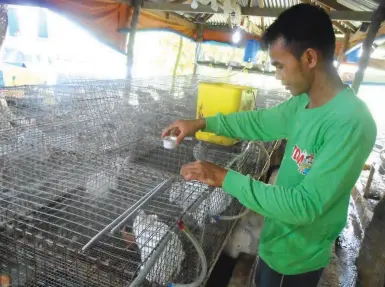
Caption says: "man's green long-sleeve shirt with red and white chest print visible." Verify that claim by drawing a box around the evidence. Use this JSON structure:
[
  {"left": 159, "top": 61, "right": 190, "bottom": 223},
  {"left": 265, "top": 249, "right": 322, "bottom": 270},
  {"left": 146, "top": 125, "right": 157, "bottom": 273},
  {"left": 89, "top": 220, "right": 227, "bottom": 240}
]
[{"left": 205, "top": 87, "right": 376, "bottom": 275}]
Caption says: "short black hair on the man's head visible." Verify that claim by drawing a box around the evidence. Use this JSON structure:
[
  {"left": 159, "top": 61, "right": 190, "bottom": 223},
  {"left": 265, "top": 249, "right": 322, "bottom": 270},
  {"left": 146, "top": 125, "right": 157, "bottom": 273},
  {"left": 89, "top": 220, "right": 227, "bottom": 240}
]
[{"left": 261, "top": 4, "right": 336, "bottom": 61}]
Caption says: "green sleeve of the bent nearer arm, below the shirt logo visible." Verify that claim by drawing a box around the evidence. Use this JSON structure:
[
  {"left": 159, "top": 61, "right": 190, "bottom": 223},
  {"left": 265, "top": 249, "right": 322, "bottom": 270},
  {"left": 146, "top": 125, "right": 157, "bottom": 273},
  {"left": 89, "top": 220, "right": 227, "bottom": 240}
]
[{"left": 223, "top": 118, "right": 376, "bottom": 225}]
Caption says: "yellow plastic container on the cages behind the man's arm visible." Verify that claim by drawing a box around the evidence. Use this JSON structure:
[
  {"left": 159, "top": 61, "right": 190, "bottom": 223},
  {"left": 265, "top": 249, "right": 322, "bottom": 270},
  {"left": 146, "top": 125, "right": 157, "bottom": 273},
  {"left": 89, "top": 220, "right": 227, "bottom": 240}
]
[{"left": 195, "top": 83, "right": 256, "bottom": 146}]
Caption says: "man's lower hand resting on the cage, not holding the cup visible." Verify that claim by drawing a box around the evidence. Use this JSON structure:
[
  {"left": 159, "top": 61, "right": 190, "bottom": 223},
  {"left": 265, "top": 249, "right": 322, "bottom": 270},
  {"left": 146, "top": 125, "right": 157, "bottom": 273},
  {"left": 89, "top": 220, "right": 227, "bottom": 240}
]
[{"left": 180, "top": 161, "right": 228, "bottom": 187}]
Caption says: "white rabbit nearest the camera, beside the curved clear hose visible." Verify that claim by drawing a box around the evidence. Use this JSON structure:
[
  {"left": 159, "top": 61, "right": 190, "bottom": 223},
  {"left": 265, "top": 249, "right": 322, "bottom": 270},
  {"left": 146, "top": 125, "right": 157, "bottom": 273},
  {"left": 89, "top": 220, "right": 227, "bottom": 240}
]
[{"left": 133, "top": 210, "right": 185, "bottom": 285}]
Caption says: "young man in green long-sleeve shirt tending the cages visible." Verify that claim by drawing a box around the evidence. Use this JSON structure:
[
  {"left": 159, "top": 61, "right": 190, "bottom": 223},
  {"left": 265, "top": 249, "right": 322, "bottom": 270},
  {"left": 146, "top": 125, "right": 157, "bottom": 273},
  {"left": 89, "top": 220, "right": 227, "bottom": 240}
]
[{"left": 163, "top": 4, "right": 376, "bottom": 287}]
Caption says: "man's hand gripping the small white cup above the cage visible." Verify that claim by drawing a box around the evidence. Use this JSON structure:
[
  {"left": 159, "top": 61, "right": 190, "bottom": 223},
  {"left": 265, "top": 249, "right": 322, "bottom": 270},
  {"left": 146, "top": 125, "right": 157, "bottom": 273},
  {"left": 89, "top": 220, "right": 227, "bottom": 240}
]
[{"left": 162, "top": 119, "right": 206, "bottom": 144}]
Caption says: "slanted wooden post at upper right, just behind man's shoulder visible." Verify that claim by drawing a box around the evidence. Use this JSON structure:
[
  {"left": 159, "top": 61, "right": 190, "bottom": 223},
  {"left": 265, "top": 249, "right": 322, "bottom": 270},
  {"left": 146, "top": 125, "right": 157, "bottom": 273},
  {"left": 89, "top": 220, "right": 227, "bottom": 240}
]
[{"left": 352, "top": 1, "right": 385, "bottom": 93}]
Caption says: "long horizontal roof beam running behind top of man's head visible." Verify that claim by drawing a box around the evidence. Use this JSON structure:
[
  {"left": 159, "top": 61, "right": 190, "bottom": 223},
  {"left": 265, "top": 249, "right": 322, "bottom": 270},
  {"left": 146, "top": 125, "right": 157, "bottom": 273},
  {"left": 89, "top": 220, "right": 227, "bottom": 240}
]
[{"left": 142, "top": 2, "right": 373, "bottom": 22}]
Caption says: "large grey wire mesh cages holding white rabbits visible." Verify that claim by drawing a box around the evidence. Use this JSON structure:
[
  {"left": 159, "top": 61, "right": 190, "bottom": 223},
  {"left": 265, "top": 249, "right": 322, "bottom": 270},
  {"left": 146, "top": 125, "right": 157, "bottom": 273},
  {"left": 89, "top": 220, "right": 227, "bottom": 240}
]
[{"left": 0, "top": 77, "right": 288, "bottom": 286}]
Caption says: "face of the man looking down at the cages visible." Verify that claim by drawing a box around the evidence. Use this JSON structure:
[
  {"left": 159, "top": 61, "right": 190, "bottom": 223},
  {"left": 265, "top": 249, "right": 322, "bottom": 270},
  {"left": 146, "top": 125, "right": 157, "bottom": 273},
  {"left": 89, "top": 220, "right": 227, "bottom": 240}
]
[{"left": 269, "top": 39, "right": 314, "bottom": 96}]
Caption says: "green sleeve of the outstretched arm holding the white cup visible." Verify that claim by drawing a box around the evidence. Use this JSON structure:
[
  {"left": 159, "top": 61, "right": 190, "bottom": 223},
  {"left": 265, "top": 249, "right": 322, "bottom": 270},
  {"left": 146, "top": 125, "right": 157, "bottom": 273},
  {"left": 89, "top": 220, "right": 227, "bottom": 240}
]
[{"left": 204, "top": 96, "right": 301, "bottom": 141}]
